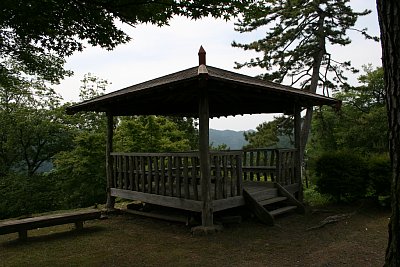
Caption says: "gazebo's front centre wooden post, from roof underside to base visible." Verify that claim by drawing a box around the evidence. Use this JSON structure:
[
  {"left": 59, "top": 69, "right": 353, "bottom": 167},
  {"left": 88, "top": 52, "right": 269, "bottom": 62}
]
[{"left": 199, "top": 86, "right": 213, "bottom": 227}]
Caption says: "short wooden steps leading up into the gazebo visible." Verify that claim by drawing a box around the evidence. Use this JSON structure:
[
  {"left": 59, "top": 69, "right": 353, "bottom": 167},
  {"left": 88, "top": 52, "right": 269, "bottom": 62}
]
[{"left": 243, "top": 183, "right": 305, "bottom": 225}]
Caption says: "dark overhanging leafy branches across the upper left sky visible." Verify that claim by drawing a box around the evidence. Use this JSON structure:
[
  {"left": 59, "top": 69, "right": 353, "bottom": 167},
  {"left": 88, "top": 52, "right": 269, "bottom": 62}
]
[{"left": 0, "top": 0, "right": 249, "bottom": 86}]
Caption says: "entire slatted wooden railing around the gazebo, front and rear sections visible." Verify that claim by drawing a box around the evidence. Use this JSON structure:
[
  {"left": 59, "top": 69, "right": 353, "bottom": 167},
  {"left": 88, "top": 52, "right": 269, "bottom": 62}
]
[{"left": 111, "top": 149, "right": 299, "bottom": 203}]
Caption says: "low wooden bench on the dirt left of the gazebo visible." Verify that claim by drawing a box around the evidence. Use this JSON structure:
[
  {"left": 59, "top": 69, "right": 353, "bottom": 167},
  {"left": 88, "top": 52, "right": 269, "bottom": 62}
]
[{"left": 0, "top": 209, "right": 101, "bottom": 240}]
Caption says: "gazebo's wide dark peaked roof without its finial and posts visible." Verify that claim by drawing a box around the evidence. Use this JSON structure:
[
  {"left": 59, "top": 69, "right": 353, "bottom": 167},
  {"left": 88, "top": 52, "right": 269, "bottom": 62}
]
[{"left": 67, "top": 66, "right": 340, "bottom": 117}]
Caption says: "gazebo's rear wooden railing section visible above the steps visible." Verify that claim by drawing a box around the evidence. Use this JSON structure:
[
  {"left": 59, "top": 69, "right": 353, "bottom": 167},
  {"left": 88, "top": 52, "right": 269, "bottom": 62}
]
[{"left": 243, "top": 148, "right": 297, "bottom": 185}]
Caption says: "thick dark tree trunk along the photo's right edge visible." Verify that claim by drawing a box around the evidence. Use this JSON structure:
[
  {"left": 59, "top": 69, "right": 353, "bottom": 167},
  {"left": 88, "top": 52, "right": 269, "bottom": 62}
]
[{"left": 377, "top": 0, "right": 400, "bottom": 266}]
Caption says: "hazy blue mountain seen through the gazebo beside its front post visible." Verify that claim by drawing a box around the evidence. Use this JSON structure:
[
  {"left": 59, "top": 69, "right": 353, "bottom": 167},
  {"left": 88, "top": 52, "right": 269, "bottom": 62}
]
[{"left": 210, "top": 129, "right": 247, "bottom": 149}]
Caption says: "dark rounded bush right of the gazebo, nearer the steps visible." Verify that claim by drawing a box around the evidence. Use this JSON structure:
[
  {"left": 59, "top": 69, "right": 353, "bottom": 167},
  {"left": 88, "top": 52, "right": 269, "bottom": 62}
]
[{"left": 315, "top": 151, "right": 368, "bottom": 201}]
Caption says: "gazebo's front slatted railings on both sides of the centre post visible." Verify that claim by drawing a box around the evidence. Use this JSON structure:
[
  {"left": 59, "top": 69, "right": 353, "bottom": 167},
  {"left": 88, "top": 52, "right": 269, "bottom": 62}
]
[{"left": 111, "top": 151, "right": 242, "bottom": 200}]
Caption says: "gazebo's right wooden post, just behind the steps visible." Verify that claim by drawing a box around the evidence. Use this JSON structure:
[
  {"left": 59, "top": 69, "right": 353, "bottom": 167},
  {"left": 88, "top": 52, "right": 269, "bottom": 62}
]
[{"left": 294, "top": 105, "right": 303, "bottom": 202}]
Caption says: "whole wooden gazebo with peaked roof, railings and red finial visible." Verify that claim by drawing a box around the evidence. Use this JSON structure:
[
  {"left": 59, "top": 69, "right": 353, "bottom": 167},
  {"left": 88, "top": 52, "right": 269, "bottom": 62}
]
[{"left": 67, "top": 47, "right": 340, "bottom": 229}]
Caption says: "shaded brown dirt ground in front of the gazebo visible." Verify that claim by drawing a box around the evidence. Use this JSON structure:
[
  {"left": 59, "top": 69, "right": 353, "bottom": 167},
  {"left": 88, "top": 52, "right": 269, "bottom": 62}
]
[{"left": 0, "top": 205, "right": 390, "bottom": 267}]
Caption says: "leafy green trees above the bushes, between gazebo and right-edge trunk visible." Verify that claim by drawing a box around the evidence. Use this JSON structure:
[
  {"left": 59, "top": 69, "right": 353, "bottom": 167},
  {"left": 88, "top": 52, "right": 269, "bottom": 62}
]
[{"left": 307, "top": 67, "right": 388, "bottom": 158}]
